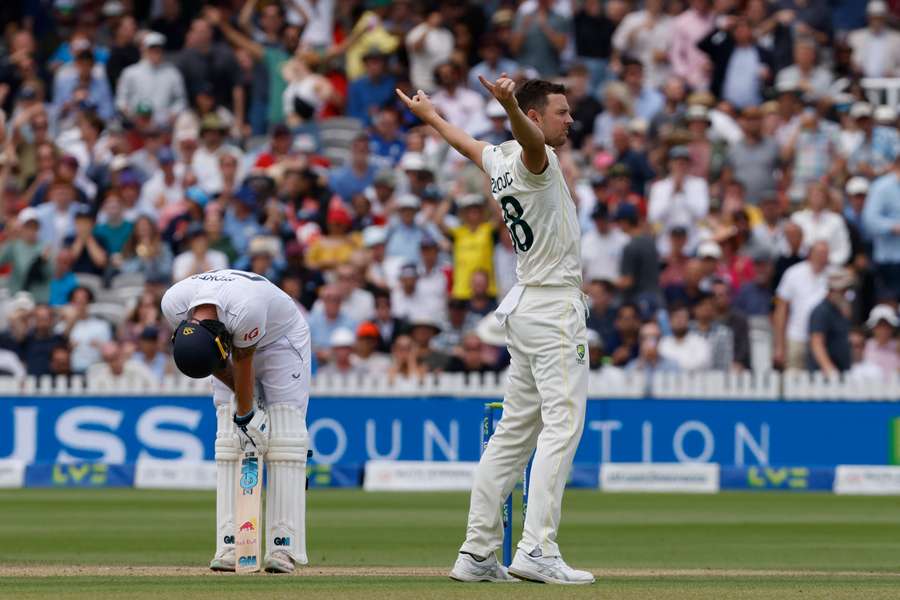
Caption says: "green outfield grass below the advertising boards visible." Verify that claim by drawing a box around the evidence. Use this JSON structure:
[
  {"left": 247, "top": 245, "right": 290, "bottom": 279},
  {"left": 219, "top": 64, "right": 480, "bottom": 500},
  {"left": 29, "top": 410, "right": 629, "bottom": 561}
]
[{"left": 0, "top": 489, "right": 900, "bottom": 600}]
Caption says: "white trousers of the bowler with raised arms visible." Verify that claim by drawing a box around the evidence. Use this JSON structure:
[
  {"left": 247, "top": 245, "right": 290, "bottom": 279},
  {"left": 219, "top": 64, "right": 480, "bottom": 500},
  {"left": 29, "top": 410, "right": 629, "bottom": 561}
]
[{"left": 460, "top": 287, "right": 588, "bottom": 556}]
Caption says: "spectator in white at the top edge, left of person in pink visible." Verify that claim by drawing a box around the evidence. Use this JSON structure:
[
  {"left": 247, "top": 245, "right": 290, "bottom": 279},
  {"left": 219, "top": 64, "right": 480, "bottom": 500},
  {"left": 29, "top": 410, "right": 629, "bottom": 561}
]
[{"left": 612, "top": 0, "right": 672, "bottom": 89}]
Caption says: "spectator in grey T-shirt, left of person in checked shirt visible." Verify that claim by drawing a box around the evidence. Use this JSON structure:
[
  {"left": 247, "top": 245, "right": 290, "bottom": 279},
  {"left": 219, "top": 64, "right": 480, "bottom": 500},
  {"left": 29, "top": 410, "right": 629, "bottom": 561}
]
[{"left": 728, "top": 106, "right": 779, "bottom": 205}]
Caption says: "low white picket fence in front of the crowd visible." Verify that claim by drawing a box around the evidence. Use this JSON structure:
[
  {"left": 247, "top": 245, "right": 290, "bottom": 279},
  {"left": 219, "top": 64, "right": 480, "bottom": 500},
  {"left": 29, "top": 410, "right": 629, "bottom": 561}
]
[{"left": 0, "top": 370, "right": 900, "bottom": 402}]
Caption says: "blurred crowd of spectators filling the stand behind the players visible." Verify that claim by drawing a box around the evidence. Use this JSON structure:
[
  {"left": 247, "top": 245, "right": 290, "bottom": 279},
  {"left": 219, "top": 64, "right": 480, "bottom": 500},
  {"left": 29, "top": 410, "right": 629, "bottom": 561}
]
[{"left": 0, "top": 0, "right": 900, "bottom": 381}]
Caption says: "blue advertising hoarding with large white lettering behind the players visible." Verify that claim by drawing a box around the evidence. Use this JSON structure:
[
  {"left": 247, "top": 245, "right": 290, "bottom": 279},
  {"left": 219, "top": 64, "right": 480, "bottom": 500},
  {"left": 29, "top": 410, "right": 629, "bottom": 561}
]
[{"left": 0, "top": 396, "right": 900, "bottom": 467}]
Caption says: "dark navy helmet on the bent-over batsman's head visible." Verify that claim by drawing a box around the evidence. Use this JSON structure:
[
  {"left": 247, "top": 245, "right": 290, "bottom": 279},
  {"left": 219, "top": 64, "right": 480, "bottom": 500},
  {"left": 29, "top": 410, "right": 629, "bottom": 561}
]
[{"left": 172, "top": 319, "right": 231, "bottom": 379}]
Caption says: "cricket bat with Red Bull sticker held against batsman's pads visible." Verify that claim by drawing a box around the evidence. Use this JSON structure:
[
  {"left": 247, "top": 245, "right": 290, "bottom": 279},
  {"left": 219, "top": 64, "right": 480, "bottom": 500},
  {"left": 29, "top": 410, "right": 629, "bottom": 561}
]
[{"left": 234, "top": 450, "right": 263, "bottom": 573}]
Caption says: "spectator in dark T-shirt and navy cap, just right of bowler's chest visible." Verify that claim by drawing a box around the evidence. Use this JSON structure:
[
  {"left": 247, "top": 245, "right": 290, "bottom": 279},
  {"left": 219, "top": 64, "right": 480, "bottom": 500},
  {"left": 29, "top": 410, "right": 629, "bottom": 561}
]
[{"left": 616, "top": 204, "right": 660, "bottom": 314}]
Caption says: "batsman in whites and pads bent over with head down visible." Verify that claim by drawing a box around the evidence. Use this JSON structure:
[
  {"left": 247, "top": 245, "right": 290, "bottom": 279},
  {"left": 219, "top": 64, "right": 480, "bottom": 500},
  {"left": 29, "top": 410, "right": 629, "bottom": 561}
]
[{"left": 162, "top": 269, "right": 310, "bottom": 573}]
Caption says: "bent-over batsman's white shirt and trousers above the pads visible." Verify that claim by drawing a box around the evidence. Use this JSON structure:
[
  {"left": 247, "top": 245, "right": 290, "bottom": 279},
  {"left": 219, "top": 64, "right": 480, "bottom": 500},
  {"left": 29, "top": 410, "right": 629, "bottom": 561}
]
[{"left": 162, "top": 269, "right": 310, "bottom": 410}]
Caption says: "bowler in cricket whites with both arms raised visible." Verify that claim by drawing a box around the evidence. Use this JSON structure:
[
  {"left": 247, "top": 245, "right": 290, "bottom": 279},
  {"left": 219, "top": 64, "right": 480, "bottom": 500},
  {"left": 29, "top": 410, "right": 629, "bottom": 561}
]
[{"left": 397, "top": 74, "right": 594, "bottom": 584}]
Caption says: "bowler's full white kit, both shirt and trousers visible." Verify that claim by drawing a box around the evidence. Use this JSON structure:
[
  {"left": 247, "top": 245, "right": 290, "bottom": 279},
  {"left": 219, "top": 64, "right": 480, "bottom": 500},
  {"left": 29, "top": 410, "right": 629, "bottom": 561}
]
[{"left": 461, "top": 141, "right": 588, "bottom": 556}]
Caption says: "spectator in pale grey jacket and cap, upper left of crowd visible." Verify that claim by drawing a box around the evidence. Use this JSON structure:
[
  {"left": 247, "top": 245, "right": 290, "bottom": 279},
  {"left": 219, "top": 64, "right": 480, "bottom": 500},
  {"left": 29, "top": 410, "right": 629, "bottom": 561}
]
[{"left": 116, "top": 31, "right": 187, "bottom": 125}]
